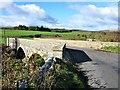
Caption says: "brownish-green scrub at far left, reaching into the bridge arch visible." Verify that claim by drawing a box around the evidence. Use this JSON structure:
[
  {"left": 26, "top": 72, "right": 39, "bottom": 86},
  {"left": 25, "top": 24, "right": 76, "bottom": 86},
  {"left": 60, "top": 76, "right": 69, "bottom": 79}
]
[{"left": 2, "top": 48, "right": 45, "bottom": 88}]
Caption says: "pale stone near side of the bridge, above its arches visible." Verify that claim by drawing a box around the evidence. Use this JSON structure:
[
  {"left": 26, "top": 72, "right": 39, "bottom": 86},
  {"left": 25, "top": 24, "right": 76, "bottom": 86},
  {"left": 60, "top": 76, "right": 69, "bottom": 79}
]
[{"left": 9, "top": 38, "right": 65, "bottom": 59}]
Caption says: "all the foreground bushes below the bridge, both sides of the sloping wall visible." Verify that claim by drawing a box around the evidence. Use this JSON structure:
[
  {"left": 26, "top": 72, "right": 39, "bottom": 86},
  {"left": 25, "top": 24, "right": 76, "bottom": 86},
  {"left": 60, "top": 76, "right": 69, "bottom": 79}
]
[{"left": 2, "top": 48, "right": 84, "bottom": 89}]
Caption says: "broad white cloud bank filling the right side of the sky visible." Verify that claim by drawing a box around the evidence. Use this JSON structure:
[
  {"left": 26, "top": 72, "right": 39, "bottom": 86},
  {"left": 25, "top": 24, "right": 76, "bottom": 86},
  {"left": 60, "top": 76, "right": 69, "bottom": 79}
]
[{"left": 67, "top": 4, "right": 118, "bottom": 30}]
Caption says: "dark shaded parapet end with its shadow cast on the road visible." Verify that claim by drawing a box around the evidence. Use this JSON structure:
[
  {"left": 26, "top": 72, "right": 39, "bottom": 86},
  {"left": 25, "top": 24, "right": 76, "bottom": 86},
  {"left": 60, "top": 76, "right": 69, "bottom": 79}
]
[{"left": 62, "top": 44, "right": 92, "bottom": 63}]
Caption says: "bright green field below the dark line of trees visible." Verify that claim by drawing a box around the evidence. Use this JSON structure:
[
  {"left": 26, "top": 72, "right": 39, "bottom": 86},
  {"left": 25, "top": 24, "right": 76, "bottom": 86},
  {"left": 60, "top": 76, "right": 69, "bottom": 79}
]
[{"left": 0, "top": 30, "right": 90, "bottom": 44}]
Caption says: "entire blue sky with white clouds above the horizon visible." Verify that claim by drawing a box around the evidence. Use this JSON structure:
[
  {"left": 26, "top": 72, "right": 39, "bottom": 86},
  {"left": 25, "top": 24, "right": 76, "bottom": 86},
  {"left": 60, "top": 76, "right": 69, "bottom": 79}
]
[{"left": 0, "top": 2, "right": 118, "bottom": 31}]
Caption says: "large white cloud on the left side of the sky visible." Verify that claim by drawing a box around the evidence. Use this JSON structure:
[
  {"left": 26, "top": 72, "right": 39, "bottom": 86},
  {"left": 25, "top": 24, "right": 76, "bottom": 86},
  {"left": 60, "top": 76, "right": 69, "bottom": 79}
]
[{"left": 1, "top": 4, "right": 57, "bottom": 26}]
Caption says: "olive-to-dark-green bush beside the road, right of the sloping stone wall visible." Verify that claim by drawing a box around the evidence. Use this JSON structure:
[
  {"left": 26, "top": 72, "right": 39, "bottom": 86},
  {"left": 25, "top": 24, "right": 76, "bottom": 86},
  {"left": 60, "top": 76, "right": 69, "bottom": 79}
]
[{"left": 36, "top": 59, "right": 84, "bottom": 90}]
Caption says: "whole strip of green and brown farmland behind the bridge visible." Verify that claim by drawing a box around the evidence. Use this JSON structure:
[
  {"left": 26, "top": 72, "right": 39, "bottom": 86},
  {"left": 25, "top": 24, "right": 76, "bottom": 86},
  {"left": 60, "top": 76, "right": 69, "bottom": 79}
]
[{"left": 0, "top": 29, "right": 120, "bottom": 44}]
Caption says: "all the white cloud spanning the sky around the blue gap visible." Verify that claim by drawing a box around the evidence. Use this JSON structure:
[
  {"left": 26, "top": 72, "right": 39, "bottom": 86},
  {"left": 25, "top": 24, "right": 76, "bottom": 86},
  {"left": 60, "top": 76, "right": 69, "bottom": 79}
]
[{"left": 0, "top": 3, "right": 118, "bottom": 30}]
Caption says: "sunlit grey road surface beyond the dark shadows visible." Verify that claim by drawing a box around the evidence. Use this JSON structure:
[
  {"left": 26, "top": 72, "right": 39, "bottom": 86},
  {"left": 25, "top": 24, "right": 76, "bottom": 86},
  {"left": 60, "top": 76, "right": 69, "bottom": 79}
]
[{"left": 69, "top": 47, "right": 120, "bottom": 88}]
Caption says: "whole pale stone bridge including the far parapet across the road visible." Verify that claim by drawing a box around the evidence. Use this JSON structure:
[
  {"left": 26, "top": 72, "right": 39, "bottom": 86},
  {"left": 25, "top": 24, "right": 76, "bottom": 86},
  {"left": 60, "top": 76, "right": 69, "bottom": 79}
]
[{"left": 8, "top": 38, "right": 118, "bottom": 58}]
